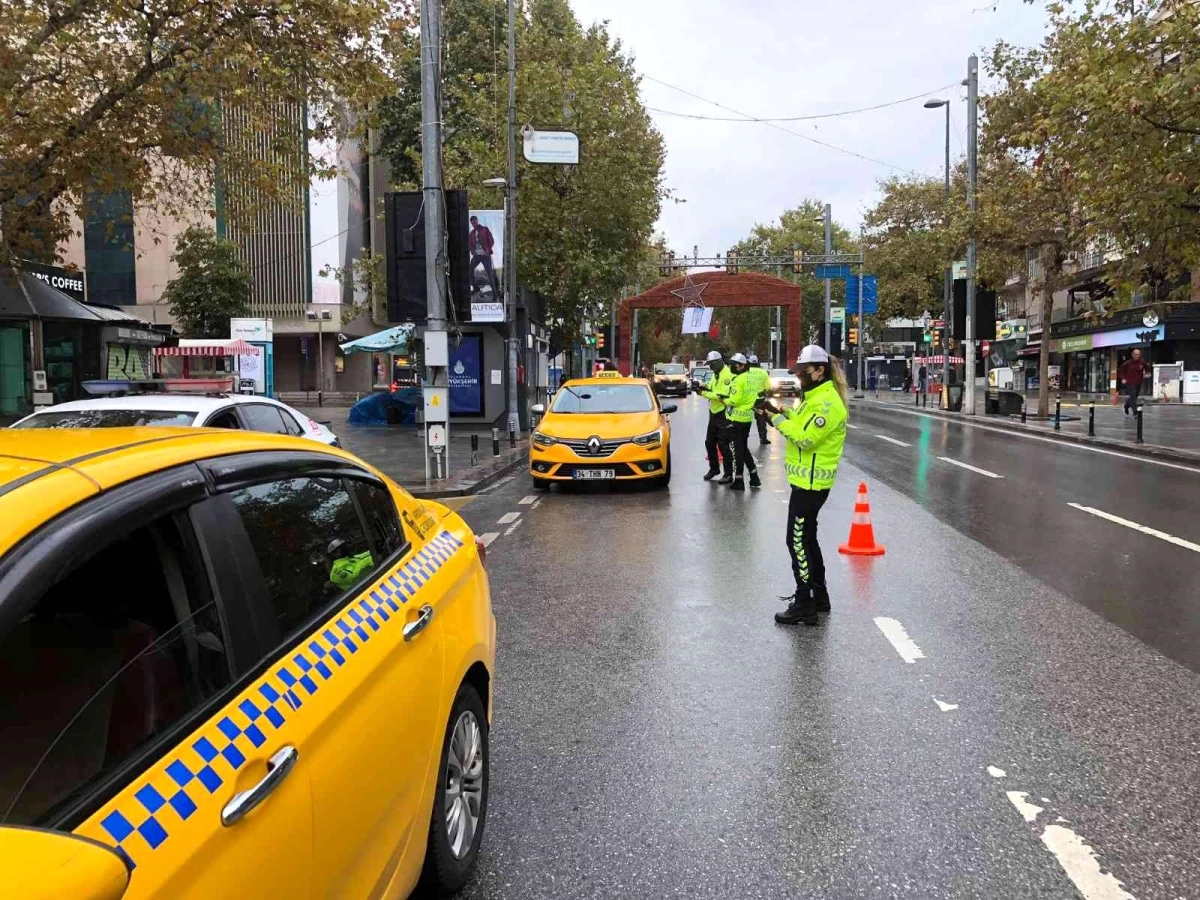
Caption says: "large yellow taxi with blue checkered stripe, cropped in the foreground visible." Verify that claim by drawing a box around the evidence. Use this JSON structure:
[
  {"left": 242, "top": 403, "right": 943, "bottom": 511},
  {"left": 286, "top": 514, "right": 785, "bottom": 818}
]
[{"left": 0, "top": 427, "right": 496, "bottom": 900}]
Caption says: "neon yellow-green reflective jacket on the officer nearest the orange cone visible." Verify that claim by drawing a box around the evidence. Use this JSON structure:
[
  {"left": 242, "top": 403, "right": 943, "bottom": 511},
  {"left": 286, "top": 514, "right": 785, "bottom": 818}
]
[{"left": 770, "top": 380, "right": 850, "bottom": 491}]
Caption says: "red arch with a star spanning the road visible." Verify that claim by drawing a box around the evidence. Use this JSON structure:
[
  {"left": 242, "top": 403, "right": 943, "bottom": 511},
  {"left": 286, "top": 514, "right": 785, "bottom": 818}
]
[{"left": 617, "top": 270, "right": 800, "bottom": 374}]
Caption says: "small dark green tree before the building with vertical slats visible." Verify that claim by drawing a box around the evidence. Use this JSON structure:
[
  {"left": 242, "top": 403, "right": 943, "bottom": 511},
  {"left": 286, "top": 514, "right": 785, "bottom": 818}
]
[{"left": 162, "top": 226, "right": 254, "bottom": 337}]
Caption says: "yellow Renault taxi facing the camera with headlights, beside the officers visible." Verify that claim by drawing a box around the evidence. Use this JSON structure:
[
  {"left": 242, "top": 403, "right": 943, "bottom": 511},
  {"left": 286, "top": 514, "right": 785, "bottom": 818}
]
[{"left": 529, "top": 372, "right": 676, "bottom": 488}]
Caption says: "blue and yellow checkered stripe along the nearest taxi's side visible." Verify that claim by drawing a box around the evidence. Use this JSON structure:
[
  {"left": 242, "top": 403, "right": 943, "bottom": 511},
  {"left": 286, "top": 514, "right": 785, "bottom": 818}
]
[{"left": 93, "top": 532, "right": 463, "bottom": 868}]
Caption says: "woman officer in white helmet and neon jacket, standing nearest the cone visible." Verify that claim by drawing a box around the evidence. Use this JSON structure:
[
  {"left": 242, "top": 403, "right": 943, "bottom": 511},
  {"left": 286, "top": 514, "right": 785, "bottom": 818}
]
[{"left": 758, "top": 344, "right": 848, "bottom": 625}]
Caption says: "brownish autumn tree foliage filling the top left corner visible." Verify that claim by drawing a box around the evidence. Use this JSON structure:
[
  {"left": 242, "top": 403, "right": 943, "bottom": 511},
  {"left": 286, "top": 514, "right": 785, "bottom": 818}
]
[{"left": 0, "top": 0, "right": 412, "bottom": 265}]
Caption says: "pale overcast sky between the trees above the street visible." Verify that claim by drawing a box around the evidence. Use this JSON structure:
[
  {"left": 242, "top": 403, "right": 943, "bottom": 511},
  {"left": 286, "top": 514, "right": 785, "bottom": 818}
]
[{"left": 570, "top": 0, "right": 1045, "bottom": 256}]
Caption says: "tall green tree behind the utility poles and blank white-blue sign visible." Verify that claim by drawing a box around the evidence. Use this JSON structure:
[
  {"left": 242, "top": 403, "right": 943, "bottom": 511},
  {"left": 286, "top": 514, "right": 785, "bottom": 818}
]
[{"left": 379, "top": 0, "right": 665, "bottom": 355}]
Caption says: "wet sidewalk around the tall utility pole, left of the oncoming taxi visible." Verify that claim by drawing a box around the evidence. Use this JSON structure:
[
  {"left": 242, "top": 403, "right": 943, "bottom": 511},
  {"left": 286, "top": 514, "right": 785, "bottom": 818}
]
[{"left": 296, "top": 406, "right": 529, "bottom": 497}]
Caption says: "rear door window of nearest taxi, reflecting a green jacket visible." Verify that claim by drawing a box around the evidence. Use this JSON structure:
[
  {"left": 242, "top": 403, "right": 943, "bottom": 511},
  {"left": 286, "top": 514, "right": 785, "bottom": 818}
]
[{"left": 232, "top": 478, "right": 376, "bottom": 638}]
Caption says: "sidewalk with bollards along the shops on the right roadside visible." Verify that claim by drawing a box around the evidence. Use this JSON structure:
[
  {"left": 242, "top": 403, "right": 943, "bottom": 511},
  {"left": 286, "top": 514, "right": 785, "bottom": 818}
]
[{"left": 856, "top": 390, "right": 1200, "bottom": 462}]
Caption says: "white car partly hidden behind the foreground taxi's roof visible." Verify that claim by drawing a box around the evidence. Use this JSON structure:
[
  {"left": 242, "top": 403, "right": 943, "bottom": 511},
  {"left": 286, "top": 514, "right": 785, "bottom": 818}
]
[{"left": 12, "top": 394, "right": 342, "bottom": 446}]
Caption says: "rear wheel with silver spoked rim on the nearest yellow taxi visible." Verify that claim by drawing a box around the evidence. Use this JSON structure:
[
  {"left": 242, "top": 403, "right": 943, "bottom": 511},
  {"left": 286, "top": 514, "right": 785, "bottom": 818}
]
[{"left": 420, "top": 684, "right": 490, "bottom": 896}]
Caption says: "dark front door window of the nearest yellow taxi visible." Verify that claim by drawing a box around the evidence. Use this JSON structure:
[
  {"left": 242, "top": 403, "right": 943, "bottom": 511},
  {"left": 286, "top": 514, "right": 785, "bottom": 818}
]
[{"left": 0, "top": 517, "right": 230, "bottom": 824}]
